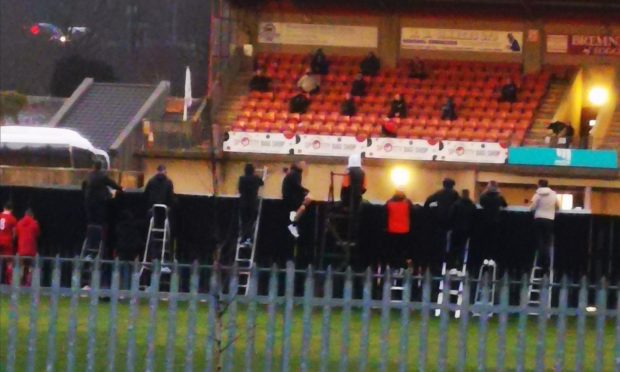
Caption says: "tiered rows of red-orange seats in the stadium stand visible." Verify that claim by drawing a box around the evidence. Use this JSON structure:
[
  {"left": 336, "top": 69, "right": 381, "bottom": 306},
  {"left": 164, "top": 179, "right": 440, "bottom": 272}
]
[{"left": 231, "top": 54, "right": 572, "bottom": 145}]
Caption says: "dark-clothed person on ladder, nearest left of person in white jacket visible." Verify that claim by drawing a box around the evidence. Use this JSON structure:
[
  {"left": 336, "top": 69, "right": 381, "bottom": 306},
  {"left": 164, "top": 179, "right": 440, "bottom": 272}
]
[{"left": 480, "top": 181, "right": 508, "bottom": 260}]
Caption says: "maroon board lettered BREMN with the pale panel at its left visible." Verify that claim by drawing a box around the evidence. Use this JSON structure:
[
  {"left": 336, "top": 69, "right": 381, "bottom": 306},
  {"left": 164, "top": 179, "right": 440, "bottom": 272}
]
[{"left": 547, "top": 35, "right": 620, "bottom": 56}]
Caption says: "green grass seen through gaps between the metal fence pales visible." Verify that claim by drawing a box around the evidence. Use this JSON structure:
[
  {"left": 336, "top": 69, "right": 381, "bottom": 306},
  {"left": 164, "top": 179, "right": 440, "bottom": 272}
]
[{"left": 0, "top": 295, "right": 614, "bottom": 371}]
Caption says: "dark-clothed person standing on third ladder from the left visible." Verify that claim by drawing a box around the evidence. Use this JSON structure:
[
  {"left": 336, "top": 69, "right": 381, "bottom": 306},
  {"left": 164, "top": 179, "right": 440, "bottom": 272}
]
[{"left": 238, "top": 163, "right": 264, "bottom": 244}]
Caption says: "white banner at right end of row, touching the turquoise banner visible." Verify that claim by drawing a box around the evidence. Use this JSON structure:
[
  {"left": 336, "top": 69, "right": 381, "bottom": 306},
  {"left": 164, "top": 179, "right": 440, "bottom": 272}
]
[{"left": 437, "top": 141, "right": 508, "bottom": 164}]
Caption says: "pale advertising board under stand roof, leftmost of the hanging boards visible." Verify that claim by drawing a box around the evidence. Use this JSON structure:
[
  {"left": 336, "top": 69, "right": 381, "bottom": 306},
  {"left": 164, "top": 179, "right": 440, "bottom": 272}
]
[{"left": 258, "top": 22, "right": 379, "bottom": 48}]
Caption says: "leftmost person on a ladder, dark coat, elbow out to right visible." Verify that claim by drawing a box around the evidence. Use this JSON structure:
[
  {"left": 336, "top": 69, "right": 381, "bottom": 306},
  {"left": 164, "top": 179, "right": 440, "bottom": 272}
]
[{"left": 82, "top": 161, "right": 123, "bottom": 226}]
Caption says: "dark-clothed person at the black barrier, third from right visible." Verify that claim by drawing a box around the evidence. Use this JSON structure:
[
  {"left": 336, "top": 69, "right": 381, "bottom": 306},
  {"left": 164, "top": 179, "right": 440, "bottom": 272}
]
[{"left": 447, "top": 189, "right": 476, "bottom": 275}]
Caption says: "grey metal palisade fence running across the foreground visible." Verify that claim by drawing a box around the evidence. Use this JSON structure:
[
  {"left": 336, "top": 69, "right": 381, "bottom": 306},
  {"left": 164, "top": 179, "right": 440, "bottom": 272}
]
[{"left": 0, "top": 257, "right": 620, "bottom": 371}]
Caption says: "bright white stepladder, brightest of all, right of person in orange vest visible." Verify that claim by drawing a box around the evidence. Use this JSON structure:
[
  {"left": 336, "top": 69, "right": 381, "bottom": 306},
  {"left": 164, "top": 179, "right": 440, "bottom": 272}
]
[{"left": 435, "top": 231, "right": 470, "bottom": 318}]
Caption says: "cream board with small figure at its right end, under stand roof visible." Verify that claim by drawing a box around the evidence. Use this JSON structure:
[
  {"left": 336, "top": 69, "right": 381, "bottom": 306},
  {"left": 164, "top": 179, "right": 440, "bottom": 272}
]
[{"left": 400, "top": 27, "right": 523, "bottom": 53}]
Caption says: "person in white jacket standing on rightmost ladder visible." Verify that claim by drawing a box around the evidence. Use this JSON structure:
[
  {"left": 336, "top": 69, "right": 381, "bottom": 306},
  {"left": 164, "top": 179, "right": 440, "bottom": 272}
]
[{"left": 530, "top": 180, "right": 560, "bottom": 270}]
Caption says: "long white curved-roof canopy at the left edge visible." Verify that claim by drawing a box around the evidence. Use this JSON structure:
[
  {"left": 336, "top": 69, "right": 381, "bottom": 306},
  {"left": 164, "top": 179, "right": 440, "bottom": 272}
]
[{"left": 0, "top": 125, "right": 110, "bottom": 169}]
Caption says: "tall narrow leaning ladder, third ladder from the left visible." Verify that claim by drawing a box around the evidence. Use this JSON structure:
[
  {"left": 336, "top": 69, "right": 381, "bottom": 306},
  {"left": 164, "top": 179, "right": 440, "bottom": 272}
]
[{"left": 235, "top": 167, "right": 267, "bottom": 295}]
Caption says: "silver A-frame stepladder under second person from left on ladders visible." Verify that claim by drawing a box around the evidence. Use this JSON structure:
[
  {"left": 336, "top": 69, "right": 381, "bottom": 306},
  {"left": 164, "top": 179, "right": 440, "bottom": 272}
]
[{"left": 140, "top": 204, "right": 174, "bottom": 282}]
